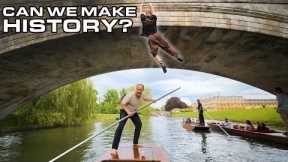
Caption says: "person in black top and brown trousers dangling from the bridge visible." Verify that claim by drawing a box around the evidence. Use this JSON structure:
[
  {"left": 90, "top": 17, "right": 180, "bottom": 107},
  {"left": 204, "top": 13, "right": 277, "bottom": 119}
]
[{"left": 140, "top": 3, "right": 183, "bottom": 73}]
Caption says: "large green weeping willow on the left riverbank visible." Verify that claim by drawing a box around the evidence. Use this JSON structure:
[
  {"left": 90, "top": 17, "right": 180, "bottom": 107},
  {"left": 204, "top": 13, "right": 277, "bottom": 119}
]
[{"left": 14, "top": 79, "right": 98, "bottom": 127}]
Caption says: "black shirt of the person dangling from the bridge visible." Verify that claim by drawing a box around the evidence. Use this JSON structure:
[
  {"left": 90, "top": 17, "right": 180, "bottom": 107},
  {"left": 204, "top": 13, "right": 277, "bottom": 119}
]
[{"left": 141, "top": 14, "right": 157, "bottom": 37}]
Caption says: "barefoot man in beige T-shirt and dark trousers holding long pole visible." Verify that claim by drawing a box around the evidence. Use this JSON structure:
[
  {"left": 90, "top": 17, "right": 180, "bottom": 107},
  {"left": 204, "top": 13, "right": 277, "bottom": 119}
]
[{"left": 111, "top": 84, "right": 153, "bottom": 155}]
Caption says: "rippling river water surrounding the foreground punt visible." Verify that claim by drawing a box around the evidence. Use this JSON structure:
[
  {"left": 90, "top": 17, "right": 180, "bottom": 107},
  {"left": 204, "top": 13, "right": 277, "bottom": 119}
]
[{"left": 0, "top": 117, "right": 288, "bottom": 162}]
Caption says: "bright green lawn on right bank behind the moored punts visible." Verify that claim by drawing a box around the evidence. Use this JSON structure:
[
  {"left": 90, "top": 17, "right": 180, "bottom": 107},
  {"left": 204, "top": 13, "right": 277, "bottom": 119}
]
[{"left": 171, "top": 108, "right": 283, "bottom": 128}]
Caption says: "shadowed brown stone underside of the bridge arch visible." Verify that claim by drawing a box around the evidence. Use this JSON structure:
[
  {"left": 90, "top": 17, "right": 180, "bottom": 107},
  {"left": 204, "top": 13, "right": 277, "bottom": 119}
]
[{"left": 0, "top": 27, "right": 288, "bottom": 118}]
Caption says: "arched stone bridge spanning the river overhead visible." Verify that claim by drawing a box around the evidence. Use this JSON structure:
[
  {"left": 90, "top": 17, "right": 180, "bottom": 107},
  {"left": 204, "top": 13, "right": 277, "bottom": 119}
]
[{"left": 0, "top": 0, "right": 288, "bottom": 118}]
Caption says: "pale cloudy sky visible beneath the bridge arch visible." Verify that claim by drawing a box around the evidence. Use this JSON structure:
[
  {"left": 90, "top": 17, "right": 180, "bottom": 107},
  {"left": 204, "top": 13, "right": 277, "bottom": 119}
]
[{"left": 89, "top": 68, "right": 275, "bottom": 108}]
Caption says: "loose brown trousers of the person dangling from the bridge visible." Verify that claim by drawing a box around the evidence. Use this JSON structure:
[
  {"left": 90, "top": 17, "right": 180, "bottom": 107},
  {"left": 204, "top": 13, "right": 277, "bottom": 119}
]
[{"left": 148, "top": 32, "right": 177, "bottom": 57}]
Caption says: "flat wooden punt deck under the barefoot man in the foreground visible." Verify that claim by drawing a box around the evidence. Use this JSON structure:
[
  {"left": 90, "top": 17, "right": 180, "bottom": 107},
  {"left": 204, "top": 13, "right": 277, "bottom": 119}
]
[{"left": 96, "top": 144, "right": 170, "bottom": 162}]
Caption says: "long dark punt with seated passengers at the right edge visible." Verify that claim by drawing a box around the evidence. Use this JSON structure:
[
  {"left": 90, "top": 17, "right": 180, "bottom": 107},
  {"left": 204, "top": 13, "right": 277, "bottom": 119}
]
[{"left": 209, "top": 123, "right": 288, "bottom": 144}]
